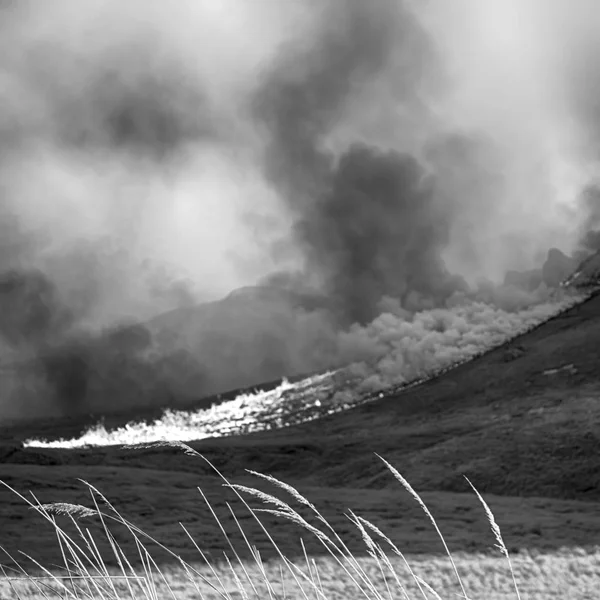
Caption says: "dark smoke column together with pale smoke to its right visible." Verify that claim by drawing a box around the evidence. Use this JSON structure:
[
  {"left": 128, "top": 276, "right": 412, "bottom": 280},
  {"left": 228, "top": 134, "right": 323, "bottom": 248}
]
[{"left": 257, "top": 0, "right": 592, "bottom": 324}]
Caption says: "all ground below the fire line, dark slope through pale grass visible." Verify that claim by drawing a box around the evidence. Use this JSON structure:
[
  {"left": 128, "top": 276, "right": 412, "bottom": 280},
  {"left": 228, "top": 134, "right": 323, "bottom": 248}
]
[{"left": 0, "top": 295, "right": 600, "bottom": 599}]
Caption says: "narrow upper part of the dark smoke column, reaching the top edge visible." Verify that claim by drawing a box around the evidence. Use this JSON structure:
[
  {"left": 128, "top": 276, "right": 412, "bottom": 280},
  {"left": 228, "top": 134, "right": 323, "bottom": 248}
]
[{"left": 255, "top": 0, "right": 398, "bottom": 199}]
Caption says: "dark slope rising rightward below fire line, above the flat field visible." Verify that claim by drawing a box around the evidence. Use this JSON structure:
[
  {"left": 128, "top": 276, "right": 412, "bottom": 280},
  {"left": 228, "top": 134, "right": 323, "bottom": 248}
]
[{"left": 5, "top": 294, "right": 600, "bottom": 500}]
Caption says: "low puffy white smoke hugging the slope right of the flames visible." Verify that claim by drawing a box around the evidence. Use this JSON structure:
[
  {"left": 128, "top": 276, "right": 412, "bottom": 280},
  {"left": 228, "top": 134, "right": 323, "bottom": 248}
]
[{"left": 338, "top": 294, "right": 582, "bottom": 402}]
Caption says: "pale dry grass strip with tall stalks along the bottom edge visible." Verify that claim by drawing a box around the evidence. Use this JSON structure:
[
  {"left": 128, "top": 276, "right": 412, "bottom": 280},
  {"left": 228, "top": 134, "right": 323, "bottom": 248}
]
[{"left": 0, "top": 443, "right": 600, "bottom": 600}]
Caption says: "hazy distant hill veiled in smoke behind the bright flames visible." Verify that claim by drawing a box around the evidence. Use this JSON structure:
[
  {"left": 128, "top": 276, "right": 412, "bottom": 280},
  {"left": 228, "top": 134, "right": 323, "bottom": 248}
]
[{"left": 0, "top": 286, "right": 327, "bottom": 423}]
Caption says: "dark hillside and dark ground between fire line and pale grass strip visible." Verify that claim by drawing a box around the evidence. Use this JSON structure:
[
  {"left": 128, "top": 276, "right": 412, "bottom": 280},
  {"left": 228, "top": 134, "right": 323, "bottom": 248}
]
[{"left": 0, "top": 293, "right": 600, "bottom": 576}]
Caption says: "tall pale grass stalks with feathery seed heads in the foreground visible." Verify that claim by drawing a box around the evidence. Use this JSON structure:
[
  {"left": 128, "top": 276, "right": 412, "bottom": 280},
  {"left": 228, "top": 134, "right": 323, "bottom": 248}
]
[{"left": 0, "top": 442, "right": 521, "bottom": 600}]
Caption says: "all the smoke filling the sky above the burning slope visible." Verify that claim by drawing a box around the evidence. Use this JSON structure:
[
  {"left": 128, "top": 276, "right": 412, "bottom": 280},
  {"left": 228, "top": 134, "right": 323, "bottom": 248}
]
[{"left": 0, "top": 0, "right": 600, "bottom": 416}]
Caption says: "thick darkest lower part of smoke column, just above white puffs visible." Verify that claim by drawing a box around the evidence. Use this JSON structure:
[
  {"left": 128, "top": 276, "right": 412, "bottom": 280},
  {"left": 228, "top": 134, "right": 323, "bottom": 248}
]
[{"left": 298, "top": 145, "right": 460, "bottom": 324}]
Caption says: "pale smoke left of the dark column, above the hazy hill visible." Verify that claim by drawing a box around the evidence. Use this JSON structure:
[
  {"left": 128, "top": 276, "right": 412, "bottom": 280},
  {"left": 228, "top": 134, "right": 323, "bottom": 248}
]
[{"left": 0, "top": 0, "right": 318, "bottom": 326}]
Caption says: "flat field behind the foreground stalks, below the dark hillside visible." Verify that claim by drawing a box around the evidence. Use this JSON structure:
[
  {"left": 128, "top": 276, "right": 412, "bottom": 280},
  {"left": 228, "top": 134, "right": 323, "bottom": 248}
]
[{"left": 0, "top": 457, "right": 600, "bottom": 600}]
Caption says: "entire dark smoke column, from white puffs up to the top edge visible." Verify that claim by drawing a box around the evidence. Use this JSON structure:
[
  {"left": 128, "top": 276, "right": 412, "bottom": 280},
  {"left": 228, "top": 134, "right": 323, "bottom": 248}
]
[{"left": 258, "top": 2, "right": 462, "bottom": 325}]
